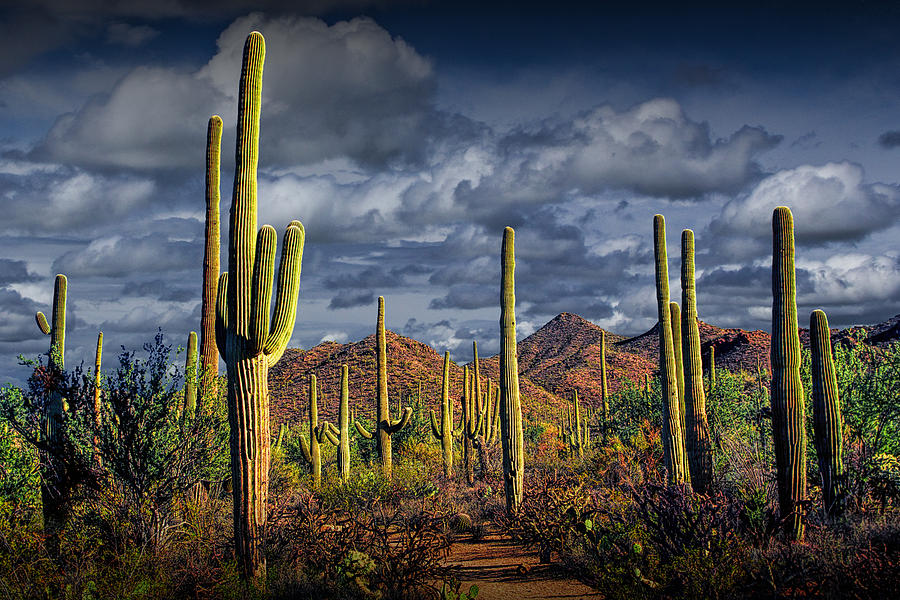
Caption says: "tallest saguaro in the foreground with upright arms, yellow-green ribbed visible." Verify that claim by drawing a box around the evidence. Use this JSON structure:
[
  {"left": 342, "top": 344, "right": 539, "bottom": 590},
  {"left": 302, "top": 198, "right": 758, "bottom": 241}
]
[{"left": 216, "top": 31, "right": 305, "bottom": 584}]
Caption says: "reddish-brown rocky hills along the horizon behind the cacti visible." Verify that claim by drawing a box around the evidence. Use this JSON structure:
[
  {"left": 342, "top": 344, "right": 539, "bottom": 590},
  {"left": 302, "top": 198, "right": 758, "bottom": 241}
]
[{"left": 269, "top": 313, "right": 900, "bottom": 426}]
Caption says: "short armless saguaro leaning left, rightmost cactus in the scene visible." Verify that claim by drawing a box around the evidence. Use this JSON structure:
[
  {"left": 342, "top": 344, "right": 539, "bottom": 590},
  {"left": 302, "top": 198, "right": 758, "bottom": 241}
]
[{"left": 809, "top": 310, "right": 845, "bottom": 518}]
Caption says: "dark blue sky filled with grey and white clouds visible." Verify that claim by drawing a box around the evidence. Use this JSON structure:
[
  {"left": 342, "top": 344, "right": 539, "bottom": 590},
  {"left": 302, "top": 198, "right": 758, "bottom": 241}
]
[{"left": 0, "top": 0, "right": 900, "bottom": 382}]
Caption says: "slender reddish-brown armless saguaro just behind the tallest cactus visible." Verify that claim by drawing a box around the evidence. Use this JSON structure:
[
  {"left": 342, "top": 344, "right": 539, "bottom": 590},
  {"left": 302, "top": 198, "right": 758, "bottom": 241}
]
[{"left": 200, "top": 115, "right": 222, "bottom": 384}]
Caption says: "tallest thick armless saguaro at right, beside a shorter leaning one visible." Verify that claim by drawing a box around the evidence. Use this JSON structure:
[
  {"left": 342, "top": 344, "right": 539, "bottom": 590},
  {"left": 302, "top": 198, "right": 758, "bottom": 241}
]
[{"left": 771, "top": 206, "right": 806, "bottom": 540}]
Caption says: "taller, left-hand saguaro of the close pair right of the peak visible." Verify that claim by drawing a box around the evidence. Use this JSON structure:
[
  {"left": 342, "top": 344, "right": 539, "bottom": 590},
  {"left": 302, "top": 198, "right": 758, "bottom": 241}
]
[{"left": 653, "top": 215, "right": 685, "bottom": 485}]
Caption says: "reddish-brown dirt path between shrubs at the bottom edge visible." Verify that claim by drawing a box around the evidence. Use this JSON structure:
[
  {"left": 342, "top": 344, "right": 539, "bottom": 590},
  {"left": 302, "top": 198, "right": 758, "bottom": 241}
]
[{"left": 446, "top": 534, "right": 603, "bottom": 600}]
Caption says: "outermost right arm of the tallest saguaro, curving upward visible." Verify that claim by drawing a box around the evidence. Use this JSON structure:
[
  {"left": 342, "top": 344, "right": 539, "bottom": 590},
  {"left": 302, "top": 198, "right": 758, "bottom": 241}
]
[{"left": 263, "top": 221, "right": 306, "bottom": 365}]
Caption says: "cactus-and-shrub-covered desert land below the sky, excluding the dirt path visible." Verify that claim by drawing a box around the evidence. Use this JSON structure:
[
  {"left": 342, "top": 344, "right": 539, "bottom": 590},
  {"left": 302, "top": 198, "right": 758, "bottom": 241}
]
[{"left": 0, "top": 32, "right": 900, "bottom": 598}]
